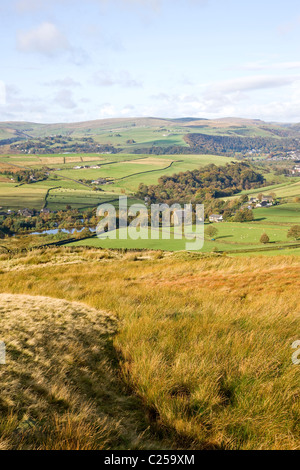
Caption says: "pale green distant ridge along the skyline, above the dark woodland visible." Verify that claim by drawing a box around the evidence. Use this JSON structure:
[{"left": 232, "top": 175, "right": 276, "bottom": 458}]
[{"left": 0, "top": 116, "right": 300, "bottom": 153}]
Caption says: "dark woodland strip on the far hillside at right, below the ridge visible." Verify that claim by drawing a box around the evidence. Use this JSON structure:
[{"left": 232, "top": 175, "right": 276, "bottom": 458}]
[{"left": 184, "top": 133, "right": 299, "bottom": 155}]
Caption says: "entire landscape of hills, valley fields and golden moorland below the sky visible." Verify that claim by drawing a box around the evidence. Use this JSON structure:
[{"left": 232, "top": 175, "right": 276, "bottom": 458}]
[{"left": 0, "top": 118, "right": 300, "bottom": 450}]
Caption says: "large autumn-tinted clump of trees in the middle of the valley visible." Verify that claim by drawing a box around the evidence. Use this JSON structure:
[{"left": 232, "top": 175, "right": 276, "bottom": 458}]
[{"left": 136, "top": 163, "right": 265, "bottom": 204}]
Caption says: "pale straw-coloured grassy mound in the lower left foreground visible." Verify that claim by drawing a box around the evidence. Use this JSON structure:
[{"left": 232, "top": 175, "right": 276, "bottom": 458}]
[{"left": 0, "top": 294, "right": 169, "bottom": 450}]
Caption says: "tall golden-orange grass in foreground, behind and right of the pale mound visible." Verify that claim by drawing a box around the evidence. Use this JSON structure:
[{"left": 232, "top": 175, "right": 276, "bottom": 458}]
[{"left": 0, "top": 248, "right": 300, "bottom": 449}]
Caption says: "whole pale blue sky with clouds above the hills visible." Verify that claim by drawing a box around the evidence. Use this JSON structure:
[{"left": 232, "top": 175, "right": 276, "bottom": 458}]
[{"left": 0, "top": 0, "right": 300, "bottom": 123}]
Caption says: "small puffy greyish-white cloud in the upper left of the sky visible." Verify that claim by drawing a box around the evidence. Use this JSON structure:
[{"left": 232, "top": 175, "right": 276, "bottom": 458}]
[{"left": 17, "top": 22, "right": 70, "bottom": 56}]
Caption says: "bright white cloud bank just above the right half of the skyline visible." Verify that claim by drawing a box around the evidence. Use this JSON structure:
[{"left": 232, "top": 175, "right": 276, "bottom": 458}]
[{"left": 148, "top": 76, "right": 300, "bottom": 122}]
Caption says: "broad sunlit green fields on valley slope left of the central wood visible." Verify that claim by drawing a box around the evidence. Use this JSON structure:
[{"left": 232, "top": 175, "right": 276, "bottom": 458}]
[{"left": 0, "top": 154, "right": 231, "bottom": 210}]
